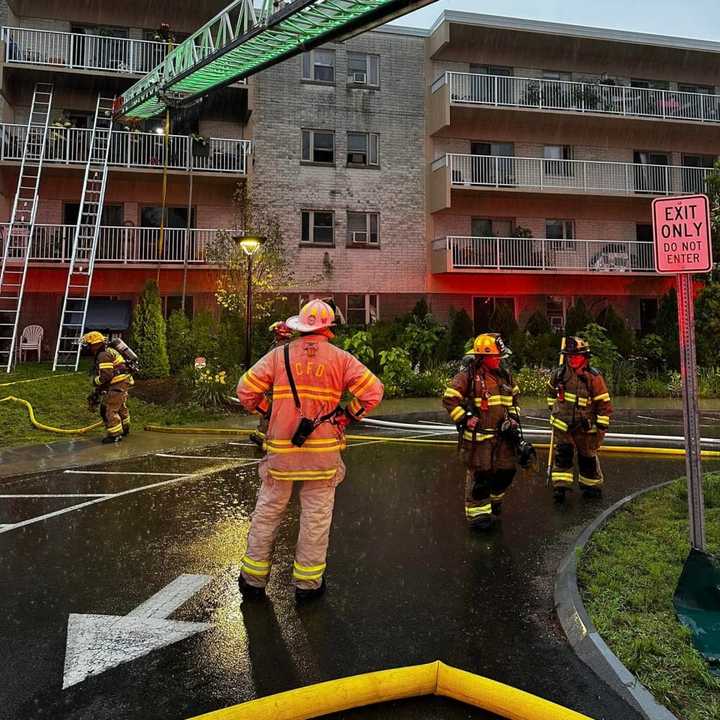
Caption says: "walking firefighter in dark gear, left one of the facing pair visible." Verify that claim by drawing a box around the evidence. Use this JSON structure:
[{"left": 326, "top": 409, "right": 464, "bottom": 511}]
[{"left": 443, "top": 333, "right": 520, "bottom": 530}]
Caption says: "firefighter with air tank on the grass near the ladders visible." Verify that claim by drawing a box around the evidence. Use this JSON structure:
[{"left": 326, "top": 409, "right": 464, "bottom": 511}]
[{"left": 82, "top": 331, "right": 135, "bottom": 443}]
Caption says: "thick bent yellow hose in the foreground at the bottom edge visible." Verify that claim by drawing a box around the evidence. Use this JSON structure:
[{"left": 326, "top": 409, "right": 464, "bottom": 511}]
[{"left": 192, "top": 660, "right": 590, "bottom": 720}]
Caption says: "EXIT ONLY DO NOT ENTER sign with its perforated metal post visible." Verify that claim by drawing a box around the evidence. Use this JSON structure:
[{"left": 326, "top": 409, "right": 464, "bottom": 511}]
[{"left": 653, "top": 195, "right": 712, "bottom": 550}]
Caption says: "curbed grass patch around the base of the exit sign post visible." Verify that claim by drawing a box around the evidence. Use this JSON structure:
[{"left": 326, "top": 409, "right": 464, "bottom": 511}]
[{"left": 578, "top": 473, "right": 720, "bottom": 720}]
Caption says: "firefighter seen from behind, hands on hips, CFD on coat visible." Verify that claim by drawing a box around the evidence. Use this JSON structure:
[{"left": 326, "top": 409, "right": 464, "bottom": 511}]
[{"left": 237, "top": 300, "right": 383, "bottom": 601}]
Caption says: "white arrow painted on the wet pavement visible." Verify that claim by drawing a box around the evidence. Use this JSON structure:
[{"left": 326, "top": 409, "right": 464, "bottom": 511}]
[{"left": 63, "top": 575, "right": 212, "bottom": 690}]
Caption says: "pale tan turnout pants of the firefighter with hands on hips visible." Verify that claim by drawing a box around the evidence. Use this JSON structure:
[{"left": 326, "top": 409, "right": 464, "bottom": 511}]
[{"left": 241, "top": 459, "right": 345, "bottom": 590}]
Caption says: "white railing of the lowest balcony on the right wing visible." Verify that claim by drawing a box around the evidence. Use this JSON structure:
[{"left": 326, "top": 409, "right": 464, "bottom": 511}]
[{"left": 431, "top": 236, "right": 655, "bottom": 275}]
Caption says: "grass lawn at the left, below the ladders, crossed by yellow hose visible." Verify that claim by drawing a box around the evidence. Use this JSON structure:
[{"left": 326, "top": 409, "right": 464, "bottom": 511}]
[{"left": 0, "top": 362, "right": 242, "bottom": 448}]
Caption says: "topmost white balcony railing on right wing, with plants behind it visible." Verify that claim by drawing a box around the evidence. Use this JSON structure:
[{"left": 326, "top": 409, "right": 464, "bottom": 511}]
[{"left": 432, "top": 72, "right": 720, "bottom": 123}]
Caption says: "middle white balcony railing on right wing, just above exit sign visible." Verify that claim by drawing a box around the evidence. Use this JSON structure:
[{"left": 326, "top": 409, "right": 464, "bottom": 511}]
[{"left": 442, "top": 153, "right": 713, "bottom": 195}]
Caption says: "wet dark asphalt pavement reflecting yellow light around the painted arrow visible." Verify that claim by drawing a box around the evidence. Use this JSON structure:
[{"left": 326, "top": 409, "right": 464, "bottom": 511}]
[{"left": 0, "top": 422, "right": 720, "bottom": 720}]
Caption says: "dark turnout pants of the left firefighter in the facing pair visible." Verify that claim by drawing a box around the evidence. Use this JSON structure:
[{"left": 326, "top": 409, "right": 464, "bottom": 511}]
[{"left": 463, "top": 437, "right": 516, "bottom": 523}]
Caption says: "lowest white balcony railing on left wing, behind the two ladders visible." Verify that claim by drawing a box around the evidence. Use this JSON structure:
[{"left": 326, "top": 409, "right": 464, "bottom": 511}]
[{"left": 0, "top": 223, "right": 217, "bottom": 265}]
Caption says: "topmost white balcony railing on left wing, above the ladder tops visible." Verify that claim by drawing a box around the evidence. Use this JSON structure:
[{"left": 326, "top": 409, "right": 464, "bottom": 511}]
[{"left": 2, "top": 27, "right": 167, "bottom": 75}]
